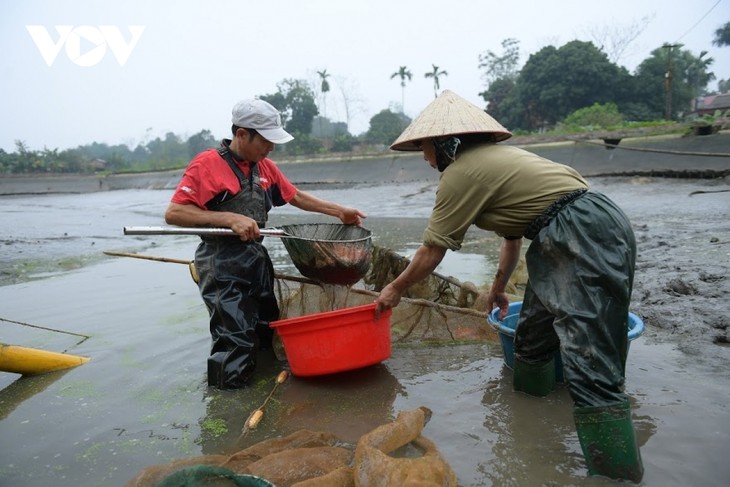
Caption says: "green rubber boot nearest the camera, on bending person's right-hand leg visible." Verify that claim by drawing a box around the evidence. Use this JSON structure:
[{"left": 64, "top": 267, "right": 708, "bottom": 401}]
[{"left": 573, "top": 402, "right": 644, "bottom": 483}]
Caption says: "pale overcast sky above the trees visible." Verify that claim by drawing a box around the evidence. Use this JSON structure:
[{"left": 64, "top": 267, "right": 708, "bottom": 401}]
[{"left": 0, "top": 0, "right": 730, "bottom": 151}]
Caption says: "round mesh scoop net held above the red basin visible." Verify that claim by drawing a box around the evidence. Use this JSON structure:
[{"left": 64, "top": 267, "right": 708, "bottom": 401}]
[{"left": 280, "top": 223, "right": 373, "bottom": 286}]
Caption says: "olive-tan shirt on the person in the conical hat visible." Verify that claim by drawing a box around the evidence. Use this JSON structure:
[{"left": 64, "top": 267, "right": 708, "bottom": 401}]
[{"left": 423, "top": 144, "right": 589, "bottom": 250}]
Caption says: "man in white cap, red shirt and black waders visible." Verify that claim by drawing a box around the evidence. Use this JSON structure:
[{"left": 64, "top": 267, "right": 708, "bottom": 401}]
[{"left": 165, "top": 99, "right": 366, "bottom": 389}]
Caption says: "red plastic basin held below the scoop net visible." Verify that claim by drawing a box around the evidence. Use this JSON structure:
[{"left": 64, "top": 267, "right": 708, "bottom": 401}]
[{"left": 269, "top": 303, "right": 391, "bottom": 377}]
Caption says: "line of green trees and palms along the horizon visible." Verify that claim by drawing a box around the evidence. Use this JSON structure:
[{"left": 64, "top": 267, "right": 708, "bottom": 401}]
[{"left": 0, "top": 22, "right": 730, "bottom": 174}]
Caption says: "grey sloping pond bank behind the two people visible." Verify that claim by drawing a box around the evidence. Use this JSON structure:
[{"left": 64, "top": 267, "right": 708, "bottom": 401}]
[{"left": 0, "top": 132, "right": 730, "bottom": 196}]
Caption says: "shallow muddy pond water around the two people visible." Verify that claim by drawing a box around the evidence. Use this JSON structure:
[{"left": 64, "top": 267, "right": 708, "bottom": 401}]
[{"left": 0, "top": 180, "right": 730, "bottom": 487}]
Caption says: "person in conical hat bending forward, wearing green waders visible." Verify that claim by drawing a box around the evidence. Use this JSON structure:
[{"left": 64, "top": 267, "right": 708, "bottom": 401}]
[{"left": 376, "top": 91, "right": 643, "bottom": 482}]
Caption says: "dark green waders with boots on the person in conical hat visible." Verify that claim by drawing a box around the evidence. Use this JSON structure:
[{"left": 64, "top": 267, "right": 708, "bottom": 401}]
[{"left": 514, "top": 192, "right": 644, "bottom": 482}]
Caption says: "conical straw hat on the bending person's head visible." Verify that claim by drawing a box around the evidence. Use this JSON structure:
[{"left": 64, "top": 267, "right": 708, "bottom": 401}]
[{"left": 390, "top": 90, "right": 512, "bottom": 151}]
